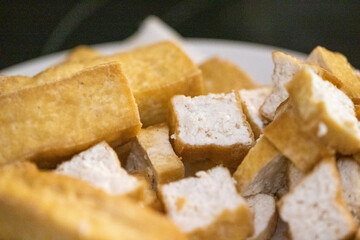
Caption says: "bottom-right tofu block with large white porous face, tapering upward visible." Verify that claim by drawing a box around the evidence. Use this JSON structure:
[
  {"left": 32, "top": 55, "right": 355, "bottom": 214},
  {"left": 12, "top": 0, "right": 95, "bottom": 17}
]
[{"left": 278, "top": 158, "right": 356, "bottom": 240}]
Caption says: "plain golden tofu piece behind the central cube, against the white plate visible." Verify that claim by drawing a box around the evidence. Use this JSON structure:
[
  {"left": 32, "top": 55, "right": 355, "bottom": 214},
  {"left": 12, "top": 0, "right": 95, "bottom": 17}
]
[{"left": 199, "top": 57, "right": 258, "bottom": 93}]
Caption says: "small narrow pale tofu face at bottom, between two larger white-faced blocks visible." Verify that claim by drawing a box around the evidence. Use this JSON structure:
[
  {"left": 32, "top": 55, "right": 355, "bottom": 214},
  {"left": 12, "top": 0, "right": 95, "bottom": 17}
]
[{"left": 246, "top": 194, "right": 276, "bottom": 239}]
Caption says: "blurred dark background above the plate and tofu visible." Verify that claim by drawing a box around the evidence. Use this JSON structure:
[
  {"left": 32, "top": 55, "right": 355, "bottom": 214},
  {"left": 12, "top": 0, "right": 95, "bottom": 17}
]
[{"left": 0, "top": 0, "right": 360, "bottom": 69}]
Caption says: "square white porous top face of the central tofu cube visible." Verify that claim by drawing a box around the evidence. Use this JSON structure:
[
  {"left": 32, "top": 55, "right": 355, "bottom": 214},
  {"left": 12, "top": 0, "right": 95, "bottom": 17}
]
[{"left": 173, "top": 93, "right": 252, "bottom": 146}]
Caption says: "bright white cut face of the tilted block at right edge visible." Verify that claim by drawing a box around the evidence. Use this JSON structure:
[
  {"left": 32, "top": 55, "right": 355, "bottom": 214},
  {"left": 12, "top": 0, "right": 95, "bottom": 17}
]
[{"left": 308, "top": 69, "right": 360, "bottom": 138}]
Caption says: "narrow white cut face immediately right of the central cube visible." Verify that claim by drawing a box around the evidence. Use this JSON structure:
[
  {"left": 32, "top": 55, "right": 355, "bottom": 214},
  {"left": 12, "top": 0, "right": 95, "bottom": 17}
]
[{"left": 239, "top": 87, "right": 271, "bottom": 129}]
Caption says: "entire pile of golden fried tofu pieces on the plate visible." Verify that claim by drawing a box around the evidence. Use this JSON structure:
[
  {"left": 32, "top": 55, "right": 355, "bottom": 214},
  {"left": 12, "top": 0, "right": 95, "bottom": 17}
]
[{"left": 0, "top": 41, "right": 360, "bottom": 240}]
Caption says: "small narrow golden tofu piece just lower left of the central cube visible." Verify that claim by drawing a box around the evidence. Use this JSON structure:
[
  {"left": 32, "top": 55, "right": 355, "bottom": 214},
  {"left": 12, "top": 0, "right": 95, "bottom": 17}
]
[{"left": 126, "top": 123, "right": 184, "bottom": 189}]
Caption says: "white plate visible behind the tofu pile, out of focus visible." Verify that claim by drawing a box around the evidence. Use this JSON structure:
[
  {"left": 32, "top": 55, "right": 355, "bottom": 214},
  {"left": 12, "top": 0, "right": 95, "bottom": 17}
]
[{"left": 1, "top": 39, "right": 305, "bottom": 84}]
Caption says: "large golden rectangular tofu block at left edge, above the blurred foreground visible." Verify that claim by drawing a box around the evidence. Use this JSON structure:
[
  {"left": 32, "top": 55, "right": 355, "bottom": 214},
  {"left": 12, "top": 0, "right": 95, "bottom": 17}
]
[{"left": 0, "top": 64, "right": 141, "bottom": 167}]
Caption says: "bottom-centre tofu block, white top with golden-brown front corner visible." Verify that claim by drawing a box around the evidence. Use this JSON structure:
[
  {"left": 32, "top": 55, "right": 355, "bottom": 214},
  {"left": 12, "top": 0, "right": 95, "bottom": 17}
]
[{"left": 161, "top": 167, "right": 253, "bottom": 240}]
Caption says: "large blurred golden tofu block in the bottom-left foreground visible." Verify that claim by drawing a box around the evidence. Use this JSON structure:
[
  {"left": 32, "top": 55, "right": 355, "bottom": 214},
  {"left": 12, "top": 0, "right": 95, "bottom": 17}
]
[{"left": 0, "top": 162, "right": 187, "bottom": 240}]
